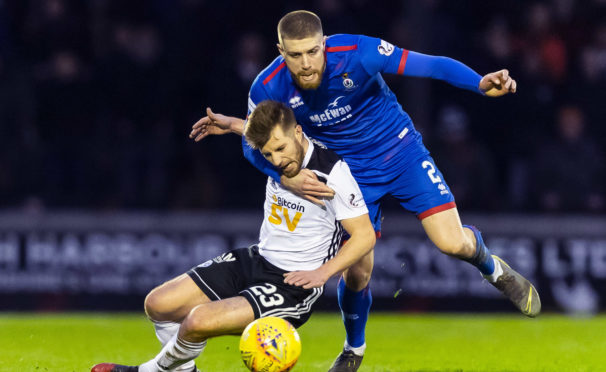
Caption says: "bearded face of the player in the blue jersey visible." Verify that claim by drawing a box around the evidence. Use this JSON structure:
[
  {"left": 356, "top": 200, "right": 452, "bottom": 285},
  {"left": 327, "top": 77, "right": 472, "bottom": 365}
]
[{"left": 278, "top": 33, "right": 326, "bottom": 89}]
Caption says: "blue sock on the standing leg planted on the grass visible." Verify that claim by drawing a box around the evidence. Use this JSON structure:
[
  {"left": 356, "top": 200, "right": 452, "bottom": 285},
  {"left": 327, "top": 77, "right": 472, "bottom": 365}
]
[{"left": 337, "top": 277, "right": 372, "bottom": 347}]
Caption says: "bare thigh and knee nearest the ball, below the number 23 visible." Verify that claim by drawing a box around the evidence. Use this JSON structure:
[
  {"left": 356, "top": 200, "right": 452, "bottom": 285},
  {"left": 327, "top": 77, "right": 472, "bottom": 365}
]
[{"left": 180, "top": 296, "right": 255, "bottom": 338}]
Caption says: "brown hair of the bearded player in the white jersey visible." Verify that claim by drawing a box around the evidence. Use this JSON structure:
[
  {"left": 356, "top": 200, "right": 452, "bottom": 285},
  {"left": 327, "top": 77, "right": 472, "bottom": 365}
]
[{"left": 244, "top": 100, "right": 297, "bottom": 149}]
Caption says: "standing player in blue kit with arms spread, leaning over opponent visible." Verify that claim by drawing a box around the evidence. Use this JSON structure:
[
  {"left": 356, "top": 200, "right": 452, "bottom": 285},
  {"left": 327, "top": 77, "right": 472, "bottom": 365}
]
[{"left": 190, "top": 11, "right": 541, "bottom": 372}]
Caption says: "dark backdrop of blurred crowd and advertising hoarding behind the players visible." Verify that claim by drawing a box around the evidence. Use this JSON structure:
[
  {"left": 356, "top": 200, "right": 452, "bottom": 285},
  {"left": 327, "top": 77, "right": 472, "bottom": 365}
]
[{"left": 0, "top": 0, "right": 606, "bottom": 313}]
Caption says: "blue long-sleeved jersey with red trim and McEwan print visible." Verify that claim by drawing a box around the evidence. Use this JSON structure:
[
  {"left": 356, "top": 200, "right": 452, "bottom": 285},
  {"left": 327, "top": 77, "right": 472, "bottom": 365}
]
[{"left": 242, "top": 34, "right": 481, "bottom": 184}]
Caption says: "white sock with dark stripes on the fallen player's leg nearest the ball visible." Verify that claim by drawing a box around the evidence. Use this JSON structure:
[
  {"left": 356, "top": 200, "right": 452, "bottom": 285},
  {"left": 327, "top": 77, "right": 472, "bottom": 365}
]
[{"left": 139, "top": 334, "right": 206, "bottom": 372}]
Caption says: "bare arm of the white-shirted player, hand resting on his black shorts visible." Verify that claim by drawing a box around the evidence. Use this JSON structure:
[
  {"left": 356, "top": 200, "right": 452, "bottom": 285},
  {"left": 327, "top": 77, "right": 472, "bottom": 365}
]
[{"left": 284, "top": 214, "right": 376, "bottom": 289}]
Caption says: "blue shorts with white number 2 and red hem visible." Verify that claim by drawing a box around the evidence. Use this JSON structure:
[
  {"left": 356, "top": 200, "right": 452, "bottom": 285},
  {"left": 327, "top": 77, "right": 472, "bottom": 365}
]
[{"left": 358, "top": 154, "right": 456, "bottom": 231}]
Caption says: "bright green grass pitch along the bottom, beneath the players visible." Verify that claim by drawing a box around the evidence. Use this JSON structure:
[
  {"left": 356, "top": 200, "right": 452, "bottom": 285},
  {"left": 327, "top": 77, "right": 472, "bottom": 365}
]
[{"left": 0, "top": 312, "right": 606, "bottom": 372}]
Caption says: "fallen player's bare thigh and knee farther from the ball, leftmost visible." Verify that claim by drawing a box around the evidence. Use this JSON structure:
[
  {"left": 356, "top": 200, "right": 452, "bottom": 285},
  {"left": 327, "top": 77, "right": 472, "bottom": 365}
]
[{"left": 145, "top": 274, "right": 211, "bottom": 321}]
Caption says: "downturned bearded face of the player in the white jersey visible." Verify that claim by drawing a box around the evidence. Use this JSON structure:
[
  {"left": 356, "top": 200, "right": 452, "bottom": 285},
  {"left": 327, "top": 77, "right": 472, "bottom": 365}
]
[{"left": 261, "top": 125, "right": 305, "bottom": 178}]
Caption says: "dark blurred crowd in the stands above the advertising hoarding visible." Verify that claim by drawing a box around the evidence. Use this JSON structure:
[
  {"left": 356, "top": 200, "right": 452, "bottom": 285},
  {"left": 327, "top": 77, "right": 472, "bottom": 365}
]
[{"left": 0, "top": 0, "right": 606, "bottom": 213}]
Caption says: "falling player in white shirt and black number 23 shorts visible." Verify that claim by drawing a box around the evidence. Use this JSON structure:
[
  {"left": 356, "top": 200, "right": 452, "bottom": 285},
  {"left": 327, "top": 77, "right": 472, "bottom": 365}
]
[{"left": 92, "top": 101, "right": 375, "bottom": 372}]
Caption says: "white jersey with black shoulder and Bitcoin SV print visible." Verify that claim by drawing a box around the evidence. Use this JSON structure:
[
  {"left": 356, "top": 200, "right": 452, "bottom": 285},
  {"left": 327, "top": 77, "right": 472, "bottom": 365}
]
[{"left": 259, "top": 140, "right": 368, "bottom": 271}]
